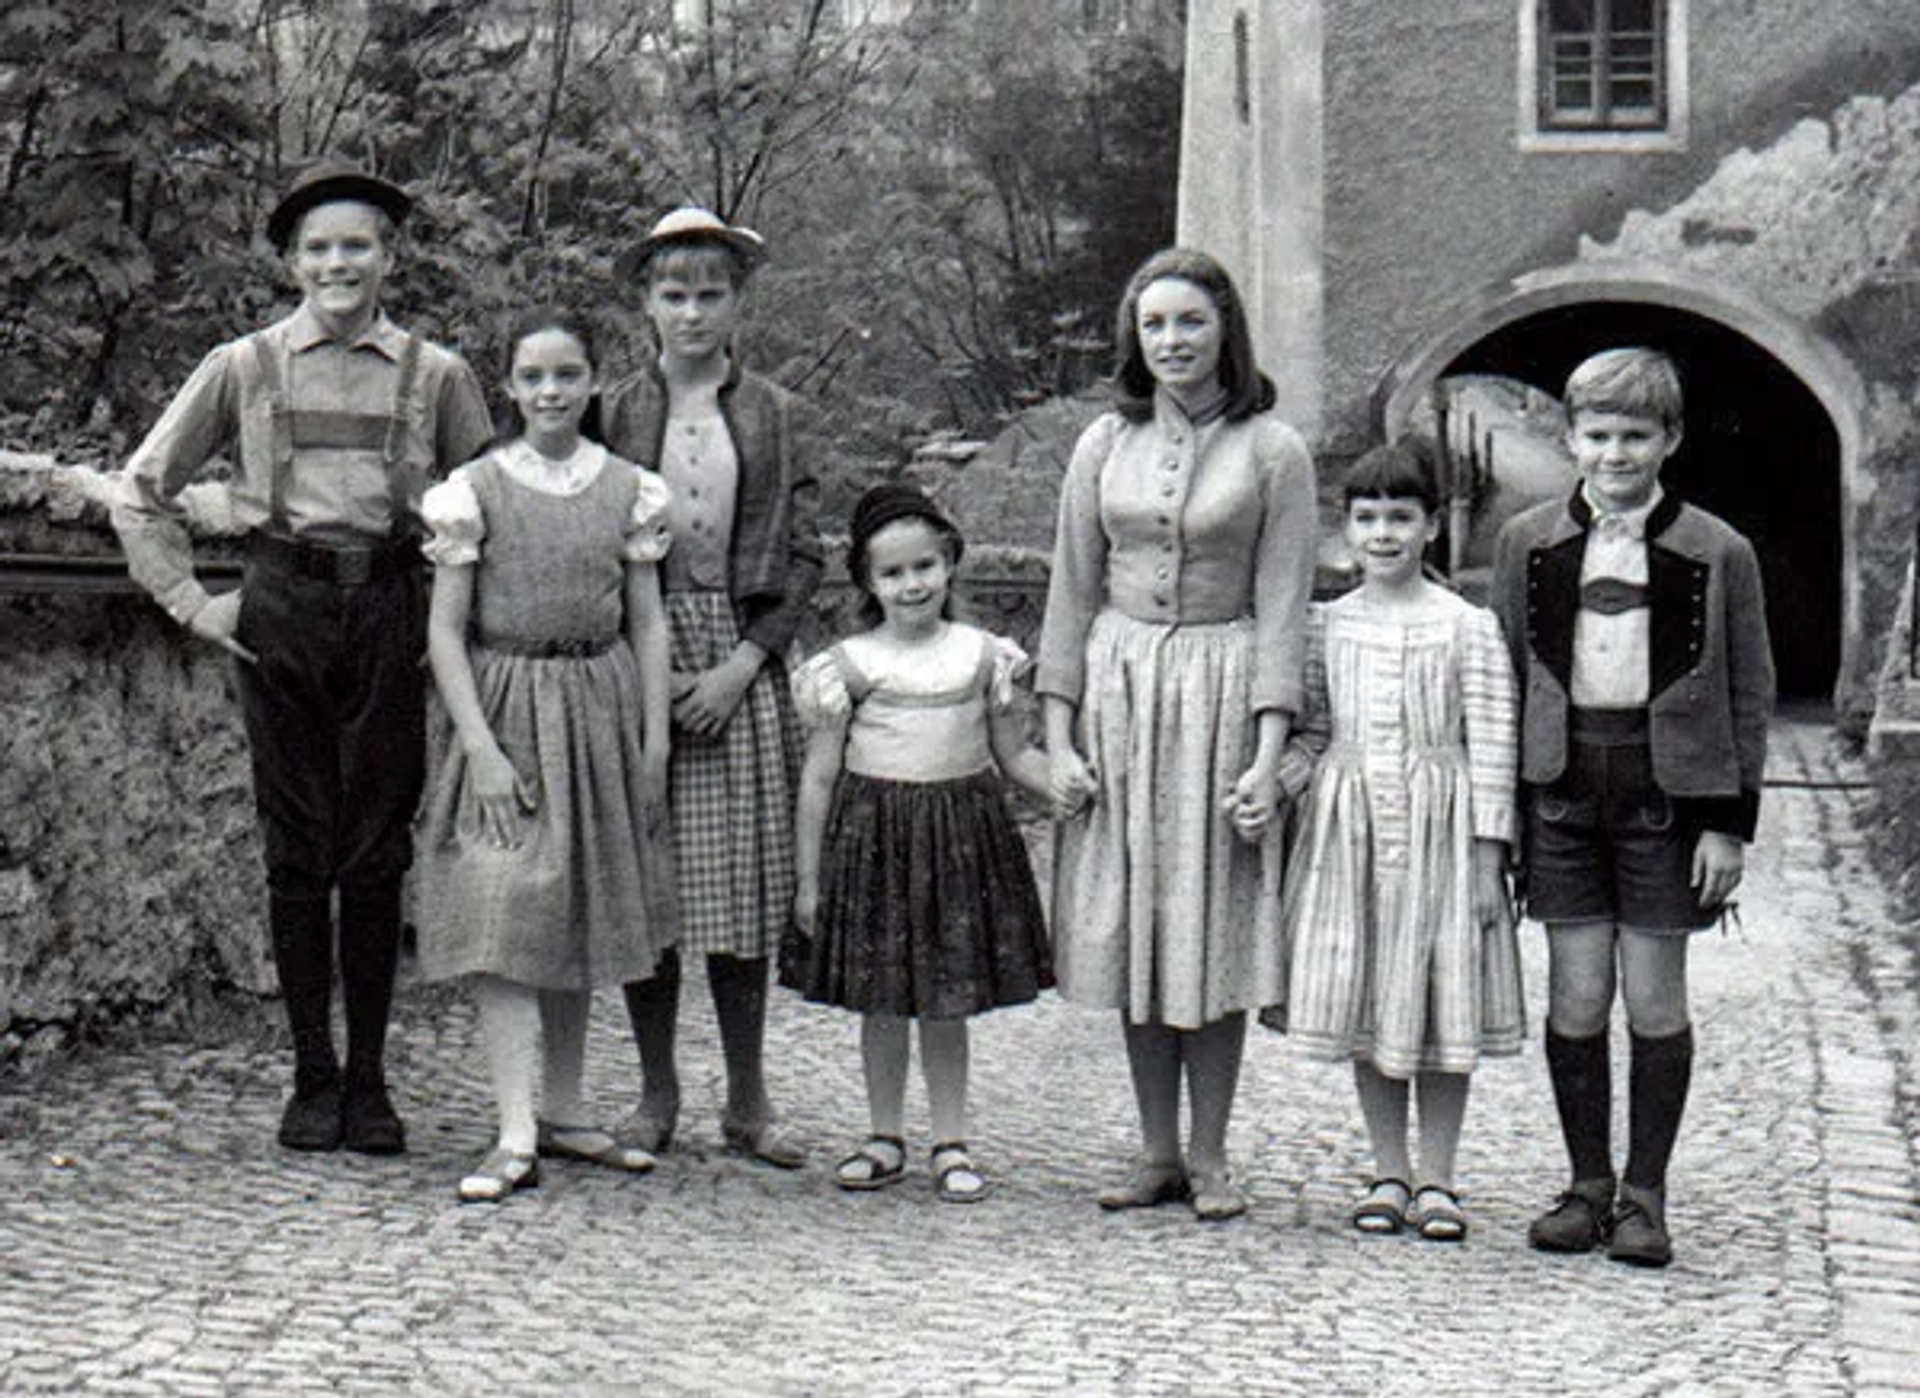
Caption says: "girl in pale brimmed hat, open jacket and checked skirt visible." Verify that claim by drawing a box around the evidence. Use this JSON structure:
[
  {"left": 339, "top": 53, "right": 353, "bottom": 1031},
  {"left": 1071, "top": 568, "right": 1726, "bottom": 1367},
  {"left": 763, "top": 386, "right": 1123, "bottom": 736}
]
[{"left": 605, "top": 207, "right": 822, "bottom": 1169}]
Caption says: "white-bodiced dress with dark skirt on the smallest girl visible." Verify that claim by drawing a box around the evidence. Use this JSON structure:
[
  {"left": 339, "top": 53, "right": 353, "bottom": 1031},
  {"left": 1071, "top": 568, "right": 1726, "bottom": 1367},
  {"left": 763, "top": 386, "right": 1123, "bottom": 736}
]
[{"left": 793, "top": 622, "right": 1054, "bottom": 1018}]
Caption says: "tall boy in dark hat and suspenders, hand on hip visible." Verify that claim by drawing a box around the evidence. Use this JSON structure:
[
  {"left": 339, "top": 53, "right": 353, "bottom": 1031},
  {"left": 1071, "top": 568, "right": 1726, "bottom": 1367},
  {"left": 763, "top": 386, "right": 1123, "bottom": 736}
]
[{"left": 113, "top": 161, "right": 492, "bottom": 1154}]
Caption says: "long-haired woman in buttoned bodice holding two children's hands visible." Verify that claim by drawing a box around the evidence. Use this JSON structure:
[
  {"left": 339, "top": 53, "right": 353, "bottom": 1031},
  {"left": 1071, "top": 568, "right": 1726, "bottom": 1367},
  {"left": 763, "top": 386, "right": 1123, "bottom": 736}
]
[{"left": 1035, "top": 248, "right": 1315, "bottom": 1219}]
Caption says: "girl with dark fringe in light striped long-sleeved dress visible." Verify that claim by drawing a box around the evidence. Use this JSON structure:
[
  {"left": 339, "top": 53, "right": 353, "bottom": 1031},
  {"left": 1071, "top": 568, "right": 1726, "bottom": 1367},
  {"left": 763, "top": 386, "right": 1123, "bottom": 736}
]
[{"left": 1263, "top": 444, "right": 1524, "bottom": 1242}]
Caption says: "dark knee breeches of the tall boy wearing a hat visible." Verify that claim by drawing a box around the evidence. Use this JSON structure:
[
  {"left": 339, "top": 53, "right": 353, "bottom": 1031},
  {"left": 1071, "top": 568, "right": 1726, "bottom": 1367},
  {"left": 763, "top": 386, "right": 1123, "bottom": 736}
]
[{"left": 234, "top": 532, "right": 426, "bottom": 897}]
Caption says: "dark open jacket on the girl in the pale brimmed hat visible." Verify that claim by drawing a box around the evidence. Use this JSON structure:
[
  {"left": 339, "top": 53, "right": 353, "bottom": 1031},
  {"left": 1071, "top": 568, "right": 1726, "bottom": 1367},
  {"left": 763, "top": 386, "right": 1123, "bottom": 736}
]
[{"left": 601, "top": 351, "right": 826, "bottom": 661}]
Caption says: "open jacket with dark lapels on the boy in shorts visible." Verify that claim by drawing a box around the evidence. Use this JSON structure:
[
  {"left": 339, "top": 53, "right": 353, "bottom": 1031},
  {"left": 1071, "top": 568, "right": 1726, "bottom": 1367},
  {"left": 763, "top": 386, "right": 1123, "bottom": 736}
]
[{"left": 1494, "top": 490, "right": 1774, "bottom": 841}]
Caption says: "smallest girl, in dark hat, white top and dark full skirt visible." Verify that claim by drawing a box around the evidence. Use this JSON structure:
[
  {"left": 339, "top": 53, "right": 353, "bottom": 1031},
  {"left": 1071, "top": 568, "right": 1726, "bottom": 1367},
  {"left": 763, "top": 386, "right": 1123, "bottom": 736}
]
[{"left": 793, "top": 484, "right": 1052, "bottom": 1204}]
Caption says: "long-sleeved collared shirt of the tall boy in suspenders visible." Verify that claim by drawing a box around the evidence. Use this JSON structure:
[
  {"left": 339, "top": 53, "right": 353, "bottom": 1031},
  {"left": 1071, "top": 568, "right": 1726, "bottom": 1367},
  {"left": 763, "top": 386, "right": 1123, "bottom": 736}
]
[{"left": 113, "top": 305, "right": 493, "bottom": 624}]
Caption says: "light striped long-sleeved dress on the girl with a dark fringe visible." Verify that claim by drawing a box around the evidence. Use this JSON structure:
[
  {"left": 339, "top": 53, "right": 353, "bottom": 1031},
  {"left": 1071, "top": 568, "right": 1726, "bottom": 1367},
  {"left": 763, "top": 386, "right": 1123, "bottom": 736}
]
[{"left": 1261, "top": 591, "right": 1524, "bottom": 1077}]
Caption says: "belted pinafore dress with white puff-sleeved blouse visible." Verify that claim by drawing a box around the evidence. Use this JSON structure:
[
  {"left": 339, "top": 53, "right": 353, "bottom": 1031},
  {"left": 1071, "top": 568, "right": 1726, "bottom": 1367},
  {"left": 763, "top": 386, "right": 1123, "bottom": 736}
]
[{"left": 417, "top": 444, "right": 678, "bottom": 991}]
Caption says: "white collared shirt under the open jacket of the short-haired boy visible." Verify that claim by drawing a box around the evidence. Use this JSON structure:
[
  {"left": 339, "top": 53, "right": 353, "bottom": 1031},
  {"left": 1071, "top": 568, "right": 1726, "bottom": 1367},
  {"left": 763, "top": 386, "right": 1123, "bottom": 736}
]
[{"left": 1569, "top": 486, "right": 1661, "bottom": 709}]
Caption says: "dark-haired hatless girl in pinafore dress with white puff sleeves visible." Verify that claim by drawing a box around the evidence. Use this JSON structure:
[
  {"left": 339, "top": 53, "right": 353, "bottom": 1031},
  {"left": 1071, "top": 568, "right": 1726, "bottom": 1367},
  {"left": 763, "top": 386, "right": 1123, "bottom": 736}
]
[{"left": 419, "top": 309, "right": 676, "bottom": 1202}]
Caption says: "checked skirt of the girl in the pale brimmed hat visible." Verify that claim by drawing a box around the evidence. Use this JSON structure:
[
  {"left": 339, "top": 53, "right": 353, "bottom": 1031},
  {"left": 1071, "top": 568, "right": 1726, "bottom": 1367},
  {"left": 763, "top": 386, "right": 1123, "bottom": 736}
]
[{"left": 666, "top": 591, "right": 801, "bottom": 956}]
